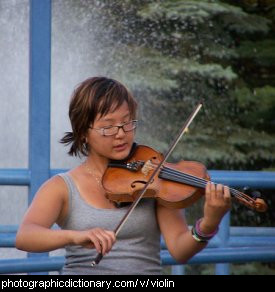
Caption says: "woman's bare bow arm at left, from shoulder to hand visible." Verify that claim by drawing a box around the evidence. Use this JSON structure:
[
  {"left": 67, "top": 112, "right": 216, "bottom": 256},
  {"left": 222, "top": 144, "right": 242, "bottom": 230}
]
[{"left": 15, "top": 176, "right": 115, "bottom": 254}]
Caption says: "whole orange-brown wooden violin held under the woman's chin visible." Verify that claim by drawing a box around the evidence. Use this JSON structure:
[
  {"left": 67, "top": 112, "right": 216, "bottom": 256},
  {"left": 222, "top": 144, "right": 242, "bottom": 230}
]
[{"left": 102, "top": 145, "right": 267, "bottom": 212}]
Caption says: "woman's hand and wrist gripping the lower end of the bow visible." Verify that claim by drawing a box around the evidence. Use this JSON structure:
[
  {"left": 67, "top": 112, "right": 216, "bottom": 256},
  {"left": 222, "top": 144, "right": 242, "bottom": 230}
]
[{"left": 73, "top": 228, "right": 116, "bottom": 255}]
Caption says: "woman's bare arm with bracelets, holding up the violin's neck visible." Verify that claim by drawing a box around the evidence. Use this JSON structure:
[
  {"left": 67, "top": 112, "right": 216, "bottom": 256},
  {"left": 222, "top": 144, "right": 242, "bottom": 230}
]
[{"left": 157, "top": 183, "right": 231, "bottom": 263}]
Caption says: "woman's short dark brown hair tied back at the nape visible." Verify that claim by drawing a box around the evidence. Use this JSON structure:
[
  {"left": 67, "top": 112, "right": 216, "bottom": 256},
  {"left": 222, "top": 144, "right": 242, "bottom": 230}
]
[{"left": 60, "top": 77, "right": 137, "bottom": 156}]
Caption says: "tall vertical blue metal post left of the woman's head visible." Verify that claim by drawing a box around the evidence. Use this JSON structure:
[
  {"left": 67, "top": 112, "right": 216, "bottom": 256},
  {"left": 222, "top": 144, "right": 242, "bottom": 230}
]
[{"left": 28, "top": 0, "right": 51, "bottom": 274}]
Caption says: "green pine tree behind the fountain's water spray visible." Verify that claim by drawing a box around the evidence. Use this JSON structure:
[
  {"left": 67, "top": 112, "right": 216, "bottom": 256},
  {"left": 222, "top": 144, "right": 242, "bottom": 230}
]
[{"left": 62, "top": 0, "right": 275, "bottom": 169}]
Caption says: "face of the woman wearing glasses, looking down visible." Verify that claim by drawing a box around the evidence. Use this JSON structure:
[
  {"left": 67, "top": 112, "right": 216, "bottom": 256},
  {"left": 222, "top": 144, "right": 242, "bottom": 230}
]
[{"left": 87, "top": 102, "right": 135, "bottom": 160}]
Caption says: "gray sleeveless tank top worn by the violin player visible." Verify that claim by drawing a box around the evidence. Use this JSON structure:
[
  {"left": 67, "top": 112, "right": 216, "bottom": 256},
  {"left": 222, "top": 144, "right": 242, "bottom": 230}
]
[{"left": 59, "top": 173, "right": 161, "bottom": 275}]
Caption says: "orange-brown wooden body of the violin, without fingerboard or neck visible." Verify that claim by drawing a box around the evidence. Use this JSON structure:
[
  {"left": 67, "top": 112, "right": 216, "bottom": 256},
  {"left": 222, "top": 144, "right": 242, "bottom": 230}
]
[{"left": 102, "top": 145, "right": 209, "bottom": 209}]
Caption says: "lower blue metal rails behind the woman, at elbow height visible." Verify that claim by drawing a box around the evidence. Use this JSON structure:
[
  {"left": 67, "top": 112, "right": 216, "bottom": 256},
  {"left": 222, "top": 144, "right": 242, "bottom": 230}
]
[{"left": 0, "top": 216, "right": 275, "bottom": 274}]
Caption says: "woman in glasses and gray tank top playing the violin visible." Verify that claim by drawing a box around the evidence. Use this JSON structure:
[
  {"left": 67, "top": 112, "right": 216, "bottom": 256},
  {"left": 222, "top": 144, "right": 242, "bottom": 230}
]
[{"left": 16, "top": 77, "right": 231, "bottom": 274}]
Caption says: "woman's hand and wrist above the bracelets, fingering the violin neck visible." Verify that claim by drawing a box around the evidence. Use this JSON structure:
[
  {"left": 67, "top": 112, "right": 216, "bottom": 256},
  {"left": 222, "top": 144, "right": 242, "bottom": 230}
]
[{"left": 200, "top": 182, "right": 231, "bottom": 234}]
